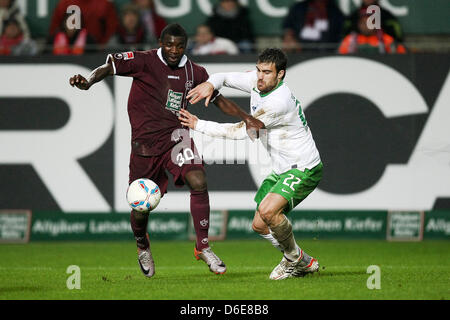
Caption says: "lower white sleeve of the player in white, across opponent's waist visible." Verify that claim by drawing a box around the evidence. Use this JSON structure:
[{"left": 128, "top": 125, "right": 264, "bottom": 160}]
[{"left": 195, "top": 119, "right": 247, "bottom": 140}]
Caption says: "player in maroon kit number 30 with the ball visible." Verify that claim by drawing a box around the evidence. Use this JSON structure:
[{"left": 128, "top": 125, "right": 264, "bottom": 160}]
[{"left": 69, "top": 24, "right": 263, "bottom": 277}]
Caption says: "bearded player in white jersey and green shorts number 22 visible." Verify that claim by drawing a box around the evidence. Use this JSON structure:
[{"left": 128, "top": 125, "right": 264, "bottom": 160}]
[{"left": 179, "top": 49, "right": 323, "bottom": 280}]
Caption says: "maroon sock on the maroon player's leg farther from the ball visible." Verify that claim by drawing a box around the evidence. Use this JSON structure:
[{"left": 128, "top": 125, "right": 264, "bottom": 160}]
[{"left": 191, "top": 190, "right": 209, "bottom": 250}]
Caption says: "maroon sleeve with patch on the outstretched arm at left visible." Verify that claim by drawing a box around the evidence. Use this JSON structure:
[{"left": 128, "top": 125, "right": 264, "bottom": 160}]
[{"left": 106, "top": 51, "right": 145, "bottom": 78}]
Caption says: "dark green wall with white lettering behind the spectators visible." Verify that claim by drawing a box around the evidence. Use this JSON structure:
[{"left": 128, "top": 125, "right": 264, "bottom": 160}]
[{"left": 6, "top": 0, "right": 450, "bottom": 52}]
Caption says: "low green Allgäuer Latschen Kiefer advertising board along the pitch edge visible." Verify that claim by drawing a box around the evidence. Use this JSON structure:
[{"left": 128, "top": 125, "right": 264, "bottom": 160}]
[{"left": 0, "top": 210, "right": 450, "bottom": 242}]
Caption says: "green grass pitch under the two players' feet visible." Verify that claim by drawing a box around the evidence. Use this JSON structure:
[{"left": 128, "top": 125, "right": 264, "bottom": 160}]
[{"left": 0, "top": 239, "right": 450, "bottom": 300}]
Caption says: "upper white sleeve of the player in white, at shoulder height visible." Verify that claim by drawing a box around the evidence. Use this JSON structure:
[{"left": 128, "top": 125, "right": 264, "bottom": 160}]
[{"left": 208, "top": 71, "right": 256, "bottom": 93}]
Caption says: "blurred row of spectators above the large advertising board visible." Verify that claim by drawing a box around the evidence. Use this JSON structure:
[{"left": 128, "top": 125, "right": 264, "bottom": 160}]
[{"left": 0, "top": 0, "right": 442, "bottom": 55}]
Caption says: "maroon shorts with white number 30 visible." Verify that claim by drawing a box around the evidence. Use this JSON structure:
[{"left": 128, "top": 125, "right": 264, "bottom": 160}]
[{"left": 129, "top": 140, "right": 204, "bottom": 195}]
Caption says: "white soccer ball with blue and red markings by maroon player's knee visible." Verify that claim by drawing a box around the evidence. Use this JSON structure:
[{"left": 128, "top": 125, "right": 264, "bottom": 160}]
[{"left": 127, "top": 178, "right": 161, "bottom": 212}]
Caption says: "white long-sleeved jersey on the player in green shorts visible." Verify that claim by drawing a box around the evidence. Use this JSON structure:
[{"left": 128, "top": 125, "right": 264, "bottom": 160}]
[{"left": 195, "top": 70, "right": 320, "bottom": 174}]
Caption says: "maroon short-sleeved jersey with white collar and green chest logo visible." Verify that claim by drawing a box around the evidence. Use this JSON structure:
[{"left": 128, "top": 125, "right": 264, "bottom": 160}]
[{"left": 107, "top": 49, "right": 218, "bottom": 156}]
